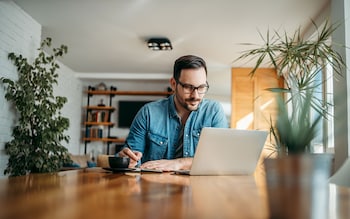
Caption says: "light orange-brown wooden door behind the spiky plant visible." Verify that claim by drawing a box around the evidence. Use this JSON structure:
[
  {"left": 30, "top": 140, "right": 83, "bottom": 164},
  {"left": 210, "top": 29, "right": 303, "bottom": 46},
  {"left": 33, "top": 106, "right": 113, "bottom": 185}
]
[{"left": 231, "top": 68, "right": 283, "bottom": 130}]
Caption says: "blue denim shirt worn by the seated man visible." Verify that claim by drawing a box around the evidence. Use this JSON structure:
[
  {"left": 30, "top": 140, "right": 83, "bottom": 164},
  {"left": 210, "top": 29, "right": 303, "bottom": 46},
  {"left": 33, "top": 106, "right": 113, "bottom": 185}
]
[{"left": 125, "top": 95, "right": 228, "bottom": 163}]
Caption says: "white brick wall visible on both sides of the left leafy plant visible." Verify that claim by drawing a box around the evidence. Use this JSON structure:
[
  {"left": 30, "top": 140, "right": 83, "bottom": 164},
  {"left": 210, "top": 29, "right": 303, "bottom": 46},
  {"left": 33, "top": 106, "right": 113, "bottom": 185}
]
[{"left": 0, "top": 1, "right": 82, "bottom": 178}]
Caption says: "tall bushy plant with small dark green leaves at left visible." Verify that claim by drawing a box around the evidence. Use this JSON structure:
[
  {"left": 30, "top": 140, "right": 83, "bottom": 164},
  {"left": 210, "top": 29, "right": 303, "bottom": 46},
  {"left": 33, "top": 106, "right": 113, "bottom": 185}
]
[{"left": 0, "top": 38, "right": 70, "bottom": 176}]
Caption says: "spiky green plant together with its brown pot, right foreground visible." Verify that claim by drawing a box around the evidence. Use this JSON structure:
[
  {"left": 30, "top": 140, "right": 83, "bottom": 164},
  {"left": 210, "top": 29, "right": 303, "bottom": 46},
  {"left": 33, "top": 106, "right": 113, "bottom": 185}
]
[{"left": 238, "top": 22, "right": 345, "bottom": 218}]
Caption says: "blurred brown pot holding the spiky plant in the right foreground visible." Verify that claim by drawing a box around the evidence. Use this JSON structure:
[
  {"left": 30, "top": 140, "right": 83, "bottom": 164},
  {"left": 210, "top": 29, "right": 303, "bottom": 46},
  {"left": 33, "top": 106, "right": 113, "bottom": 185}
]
[{"left": 264, "top": 154, "right": 332, "bottom": 219}]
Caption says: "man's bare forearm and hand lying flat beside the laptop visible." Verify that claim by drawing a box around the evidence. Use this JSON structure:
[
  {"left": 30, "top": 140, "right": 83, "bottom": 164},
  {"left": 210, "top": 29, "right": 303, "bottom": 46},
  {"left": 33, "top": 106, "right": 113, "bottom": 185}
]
[{"left": 141, "top": 158, "right": 193, "bottom": 171}]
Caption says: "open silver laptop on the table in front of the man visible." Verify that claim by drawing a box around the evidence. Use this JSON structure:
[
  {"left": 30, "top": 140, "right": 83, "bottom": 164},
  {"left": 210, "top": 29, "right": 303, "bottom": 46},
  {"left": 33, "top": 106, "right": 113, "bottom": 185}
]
[{"left": 175, "top": 127, "right": 268, "bottom": 175}]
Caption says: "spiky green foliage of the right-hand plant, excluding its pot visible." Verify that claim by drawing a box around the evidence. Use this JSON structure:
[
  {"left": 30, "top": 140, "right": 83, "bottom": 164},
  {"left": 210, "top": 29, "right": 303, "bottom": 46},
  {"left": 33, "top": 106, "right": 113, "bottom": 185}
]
[{"left": 236, "top": 22, "right": 345, "bottom": 155}]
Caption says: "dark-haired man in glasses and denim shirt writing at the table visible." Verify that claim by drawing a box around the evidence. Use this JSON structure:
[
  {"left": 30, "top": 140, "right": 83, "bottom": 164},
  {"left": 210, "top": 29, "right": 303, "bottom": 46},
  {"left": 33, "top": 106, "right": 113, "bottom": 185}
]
[{"left": 118, "top": 55, "right": 228, "bottom": 171}]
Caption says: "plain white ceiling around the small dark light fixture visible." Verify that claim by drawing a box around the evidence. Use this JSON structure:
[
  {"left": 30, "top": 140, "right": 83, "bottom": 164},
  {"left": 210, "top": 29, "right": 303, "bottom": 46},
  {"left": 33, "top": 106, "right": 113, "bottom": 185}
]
[{"left": 14, "top": 0, "right": 330, "bottom": 77}]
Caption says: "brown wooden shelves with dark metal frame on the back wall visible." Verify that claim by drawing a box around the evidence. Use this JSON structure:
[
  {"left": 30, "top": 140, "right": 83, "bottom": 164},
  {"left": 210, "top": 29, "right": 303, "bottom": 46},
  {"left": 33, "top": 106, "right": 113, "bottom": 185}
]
[{"left": 83, "top": 86, "right": 172, "bottom": 154}]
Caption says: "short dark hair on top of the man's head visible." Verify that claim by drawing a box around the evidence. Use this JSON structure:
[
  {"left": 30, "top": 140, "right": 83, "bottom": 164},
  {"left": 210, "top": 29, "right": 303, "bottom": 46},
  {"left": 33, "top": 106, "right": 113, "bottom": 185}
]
[{"left": 173, "top": 55, "right": 207, "bottom": 81}]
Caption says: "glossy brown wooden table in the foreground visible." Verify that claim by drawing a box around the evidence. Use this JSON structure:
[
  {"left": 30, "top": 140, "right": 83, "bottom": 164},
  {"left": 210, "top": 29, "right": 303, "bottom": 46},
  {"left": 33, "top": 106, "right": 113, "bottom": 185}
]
[{"left": 0, "top": 168, "right": 350, "bottom": 219}]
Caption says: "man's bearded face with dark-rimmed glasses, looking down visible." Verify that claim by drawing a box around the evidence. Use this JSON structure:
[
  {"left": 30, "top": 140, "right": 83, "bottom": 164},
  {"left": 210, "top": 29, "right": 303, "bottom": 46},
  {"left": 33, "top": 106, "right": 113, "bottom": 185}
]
[{"left": 171, "top": 68, "right": 207, "bottom": 111}]
